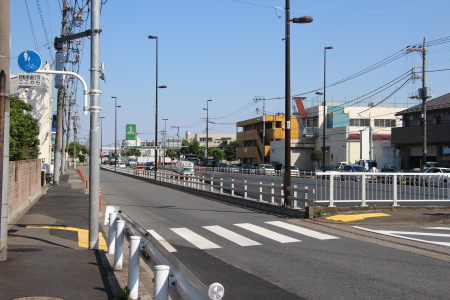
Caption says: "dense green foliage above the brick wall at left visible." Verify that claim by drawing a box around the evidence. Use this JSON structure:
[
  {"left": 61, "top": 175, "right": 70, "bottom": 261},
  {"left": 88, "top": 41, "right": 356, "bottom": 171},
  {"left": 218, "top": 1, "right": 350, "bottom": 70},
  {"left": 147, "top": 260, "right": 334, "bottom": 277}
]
[{"left": 9, "top": 97, "right": 39, "bottom": 161}]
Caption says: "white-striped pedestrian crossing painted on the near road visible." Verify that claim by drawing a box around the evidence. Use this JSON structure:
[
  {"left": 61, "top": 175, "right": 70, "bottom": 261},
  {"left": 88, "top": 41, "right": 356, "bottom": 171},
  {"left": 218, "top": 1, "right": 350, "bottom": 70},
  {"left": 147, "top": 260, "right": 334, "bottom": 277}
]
[{"left": 148, "top": 221, "right": 339, "bottom": 252}]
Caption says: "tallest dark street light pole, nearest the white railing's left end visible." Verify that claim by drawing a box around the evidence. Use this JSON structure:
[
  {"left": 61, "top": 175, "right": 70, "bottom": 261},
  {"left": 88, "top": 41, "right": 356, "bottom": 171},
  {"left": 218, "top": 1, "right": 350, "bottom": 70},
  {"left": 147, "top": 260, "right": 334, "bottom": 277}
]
[{"left": 283, "top": 0, "right": 313, "bottom": 206}]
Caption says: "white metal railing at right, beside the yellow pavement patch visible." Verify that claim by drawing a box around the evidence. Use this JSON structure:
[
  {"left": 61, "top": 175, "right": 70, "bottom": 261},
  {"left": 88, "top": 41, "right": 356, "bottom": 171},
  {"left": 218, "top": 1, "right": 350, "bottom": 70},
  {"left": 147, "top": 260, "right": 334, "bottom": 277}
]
[{"left": 315, "top": 172, "right": 450, "bottom": 207}]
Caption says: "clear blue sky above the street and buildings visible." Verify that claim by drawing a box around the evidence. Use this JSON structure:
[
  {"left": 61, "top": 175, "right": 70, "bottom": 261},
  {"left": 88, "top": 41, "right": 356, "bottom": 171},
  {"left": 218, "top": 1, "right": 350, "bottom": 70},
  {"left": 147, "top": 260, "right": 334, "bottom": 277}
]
[{"left": 7, "top": 0, "right": 450, "bottom": 145}]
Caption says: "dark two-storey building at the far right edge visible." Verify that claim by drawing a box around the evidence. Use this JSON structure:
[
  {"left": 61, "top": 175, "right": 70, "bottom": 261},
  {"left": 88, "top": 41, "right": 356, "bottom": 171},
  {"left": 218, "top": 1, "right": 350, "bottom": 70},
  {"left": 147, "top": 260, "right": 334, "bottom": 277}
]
[{"left": 392, "top": 93, "right": 450, "bottom": 170}]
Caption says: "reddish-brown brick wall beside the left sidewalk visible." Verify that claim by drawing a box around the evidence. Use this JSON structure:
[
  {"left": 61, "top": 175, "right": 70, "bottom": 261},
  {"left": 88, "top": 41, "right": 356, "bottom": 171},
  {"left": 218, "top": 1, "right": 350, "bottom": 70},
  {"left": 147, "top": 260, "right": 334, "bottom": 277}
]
[{"left": 8, "top": 159, "right": 41, "bottom": 220}]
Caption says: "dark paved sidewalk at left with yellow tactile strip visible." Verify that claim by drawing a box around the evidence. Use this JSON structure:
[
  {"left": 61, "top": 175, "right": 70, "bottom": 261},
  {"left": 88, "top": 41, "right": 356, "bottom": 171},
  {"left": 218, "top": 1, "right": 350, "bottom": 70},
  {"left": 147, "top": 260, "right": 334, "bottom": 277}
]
[{"left": 0, "top": 170, "right": 150, "bottom": 300}]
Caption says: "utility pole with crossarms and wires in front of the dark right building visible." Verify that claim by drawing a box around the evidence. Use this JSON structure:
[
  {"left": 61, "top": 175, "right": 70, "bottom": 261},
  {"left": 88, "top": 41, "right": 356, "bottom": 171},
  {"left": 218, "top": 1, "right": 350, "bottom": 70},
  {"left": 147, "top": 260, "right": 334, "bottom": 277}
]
[{"left": 406, "top": 38, "right": 431, "bottom": 169}]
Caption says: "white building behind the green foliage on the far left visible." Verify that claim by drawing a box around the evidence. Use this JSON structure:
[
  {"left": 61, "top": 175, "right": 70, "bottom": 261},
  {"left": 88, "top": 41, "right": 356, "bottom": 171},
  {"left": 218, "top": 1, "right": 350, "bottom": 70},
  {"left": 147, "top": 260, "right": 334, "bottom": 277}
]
[{"left": 10, "top": 62, "right": 53, "bottom": 164}]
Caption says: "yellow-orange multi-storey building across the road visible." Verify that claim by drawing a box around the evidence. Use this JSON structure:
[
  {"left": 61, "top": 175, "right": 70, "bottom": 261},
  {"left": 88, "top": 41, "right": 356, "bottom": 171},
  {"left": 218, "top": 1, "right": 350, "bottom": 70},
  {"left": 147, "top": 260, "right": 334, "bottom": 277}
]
[{"left": 236, "top": 115, "right": 299, "bottom": 165}]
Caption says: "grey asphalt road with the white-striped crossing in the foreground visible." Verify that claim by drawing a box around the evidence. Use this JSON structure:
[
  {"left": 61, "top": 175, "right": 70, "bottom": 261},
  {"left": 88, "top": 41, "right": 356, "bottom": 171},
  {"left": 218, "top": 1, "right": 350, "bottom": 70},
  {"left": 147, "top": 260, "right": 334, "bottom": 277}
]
[{"left": 100, "top": 171, "right": 450, "bottom": 300}]
